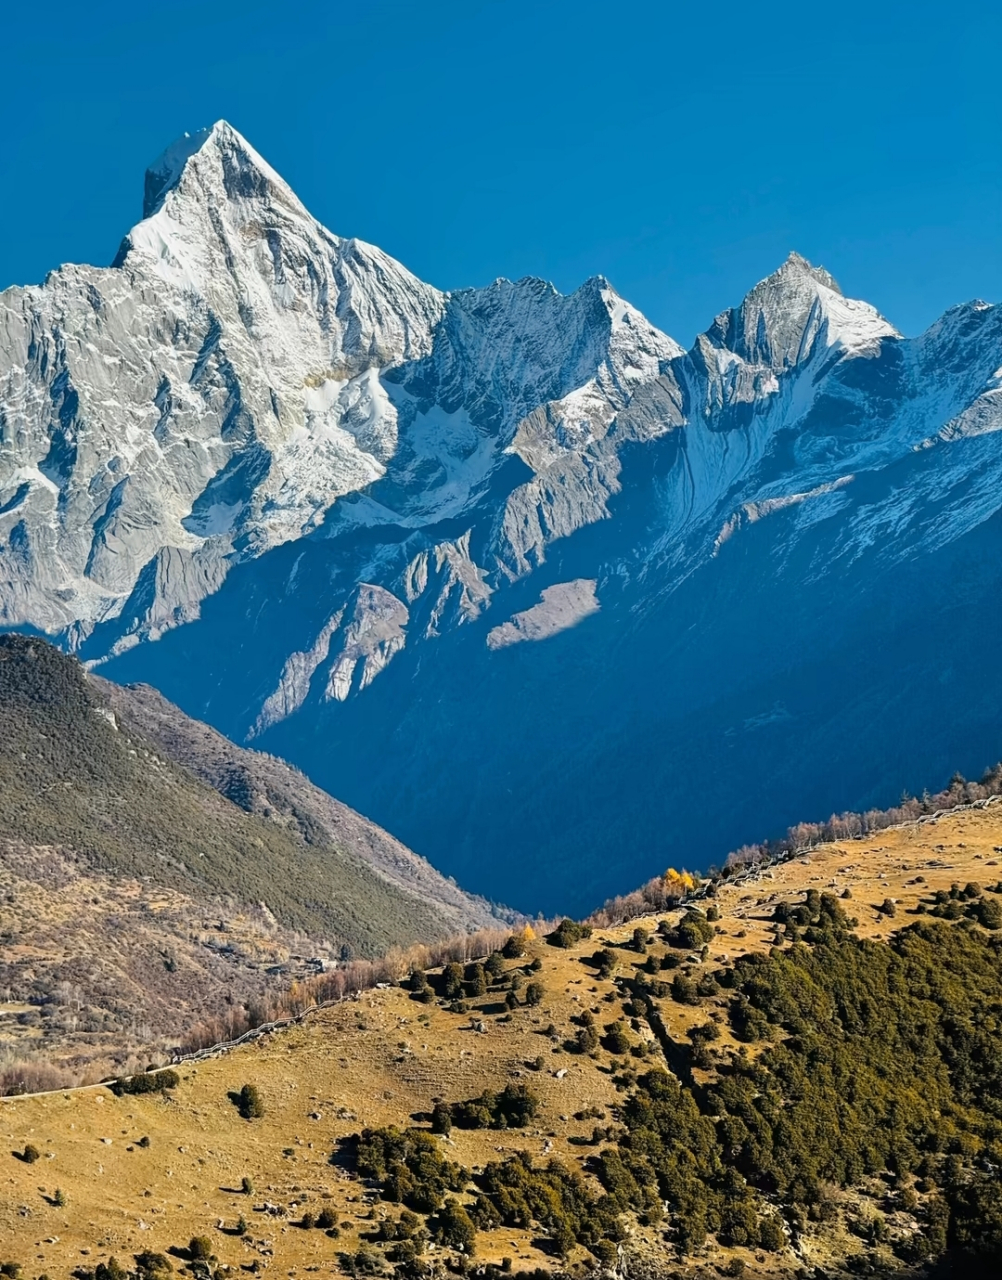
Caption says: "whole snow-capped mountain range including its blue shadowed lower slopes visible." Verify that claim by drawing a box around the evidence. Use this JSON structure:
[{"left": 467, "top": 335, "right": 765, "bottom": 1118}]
[{"left": 0, "top": 124, "right": 1002, "bottom": 909}]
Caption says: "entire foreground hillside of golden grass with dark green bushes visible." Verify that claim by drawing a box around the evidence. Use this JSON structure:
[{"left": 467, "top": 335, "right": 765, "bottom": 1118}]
[{"left": 0, "top": 803, "right": 1002, "bottom": 1280}]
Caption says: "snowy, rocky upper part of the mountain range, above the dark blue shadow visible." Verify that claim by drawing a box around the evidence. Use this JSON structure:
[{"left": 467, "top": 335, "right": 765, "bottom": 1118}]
[{"left": 0, "top": 122, "right": 1002, "bottom": 747}]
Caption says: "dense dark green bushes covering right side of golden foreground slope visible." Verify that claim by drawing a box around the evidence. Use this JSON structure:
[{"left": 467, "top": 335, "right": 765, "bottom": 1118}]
[{"left": 350, "top": 901, "right": 1002, "bottom": 1275}]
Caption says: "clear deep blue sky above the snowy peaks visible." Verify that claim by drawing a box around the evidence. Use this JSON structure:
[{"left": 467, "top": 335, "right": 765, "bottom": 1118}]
[{"left": 0, "top": 0, "right": 1002, "bottom": 343}]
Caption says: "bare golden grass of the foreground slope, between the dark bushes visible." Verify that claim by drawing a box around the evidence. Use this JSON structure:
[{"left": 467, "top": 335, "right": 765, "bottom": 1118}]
[{"left": 0, "top": 805, "right": 1002, "bottom": 1280}]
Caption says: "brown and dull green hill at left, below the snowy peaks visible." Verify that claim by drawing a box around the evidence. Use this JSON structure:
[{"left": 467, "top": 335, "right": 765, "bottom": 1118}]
[{"left": 0, "top": 635, "right": 494, "bottom": 1065}]
